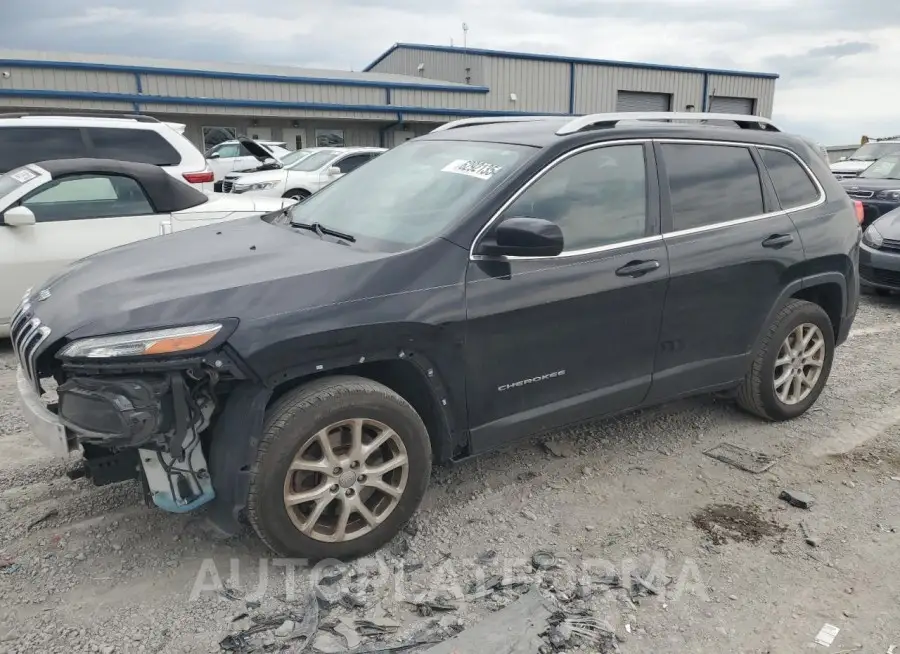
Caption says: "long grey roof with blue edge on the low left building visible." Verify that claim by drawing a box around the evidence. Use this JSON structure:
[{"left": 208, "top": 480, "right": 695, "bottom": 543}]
[{"left": 0, "top": 49, "right": 488, "bottom": 93}]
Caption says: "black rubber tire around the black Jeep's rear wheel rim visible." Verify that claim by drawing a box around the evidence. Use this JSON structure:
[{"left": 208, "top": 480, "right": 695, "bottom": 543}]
[{"left": 737, "top": 300, "right": 834, "bottom": 421}]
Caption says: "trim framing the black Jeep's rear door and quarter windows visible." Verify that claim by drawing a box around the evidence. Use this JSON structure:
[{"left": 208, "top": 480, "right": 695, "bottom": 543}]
[{"left": 653, "top": 138, "right": 825, "bottom": 238}]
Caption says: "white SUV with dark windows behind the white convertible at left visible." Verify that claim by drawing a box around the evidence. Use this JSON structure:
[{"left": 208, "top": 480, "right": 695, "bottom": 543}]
[{"left": 0, "top": 113, "right": 214, "bottom": 191}]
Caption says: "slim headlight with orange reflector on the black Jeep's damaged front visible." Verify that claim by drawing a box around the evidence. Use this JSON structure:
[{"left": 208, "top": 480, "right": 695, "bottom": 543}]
[{"left": 59, "top": 323, "right": 222, "bottom": 359}]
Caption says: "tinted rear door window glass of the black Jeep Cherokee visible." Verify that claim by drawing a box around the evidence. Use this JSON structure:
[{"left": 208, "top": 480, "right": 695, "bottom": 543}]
[{"left": 662, "top": 143, "right": 765, "bottom": 231}]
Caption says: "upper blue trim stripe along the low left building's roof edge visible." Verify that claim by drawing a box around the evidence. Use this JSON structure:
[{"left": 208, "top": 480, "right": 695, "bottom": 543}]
[{"left": 0, "top": 59, "right": 490, "bottom": 93}]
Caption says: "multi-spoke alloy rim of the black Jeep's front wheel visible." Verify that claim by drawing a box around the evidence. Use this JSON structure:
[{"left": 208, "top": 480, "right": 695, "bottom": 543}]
[{"left": 284, "top": 418, "right": 409, "bottom": 543}]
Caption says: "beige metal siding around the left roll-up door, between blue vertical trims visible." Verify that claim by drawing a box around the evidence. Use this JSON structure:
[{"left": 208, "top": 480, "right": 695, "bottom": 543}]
[{"left": 575, "top": 64, "right": 703, "bottom": 114}]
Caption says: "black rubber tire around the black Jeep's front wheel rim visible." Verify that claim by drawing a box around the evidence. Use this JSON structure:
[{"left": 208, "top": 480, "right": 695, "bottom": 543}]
[{"left": 247, "top": 376, "right": 431, "bottom": 561}]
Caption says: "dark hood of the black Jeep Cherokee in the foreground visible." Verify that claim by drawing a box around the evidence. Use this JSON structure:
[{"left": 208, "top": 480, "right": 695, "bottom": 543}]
[{"left": 34, "top": 217, "right": 391, "bottom": 345}]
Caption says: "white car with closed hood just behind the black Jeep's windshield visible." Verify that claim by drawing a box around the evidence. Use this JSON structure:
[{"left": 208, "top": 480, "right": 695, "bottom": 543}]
[{"left": 222, "top": 147, "right": 387, "bottom": 202}]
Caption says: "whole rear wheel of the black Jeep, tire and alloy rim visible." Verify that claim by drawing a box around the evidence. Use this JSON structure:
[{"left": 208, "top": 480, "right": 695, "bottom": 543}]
[{"left": 737, "top": 300, "right": 834, "bottom": 420}]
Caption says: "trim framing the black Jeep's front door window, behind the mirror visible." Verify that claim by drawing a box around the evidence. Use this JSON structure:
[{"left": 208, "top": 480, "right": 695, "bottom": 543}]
[{"left": 469, "top": 138, "right": 662, "bottom": 261}]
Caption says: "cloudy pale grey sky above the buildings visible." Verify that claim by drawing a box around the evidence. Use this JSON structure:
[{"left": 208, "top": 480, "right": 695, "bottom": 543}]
[{"left": 0, "top": 0, "right": 900, "bottom": 145}]
